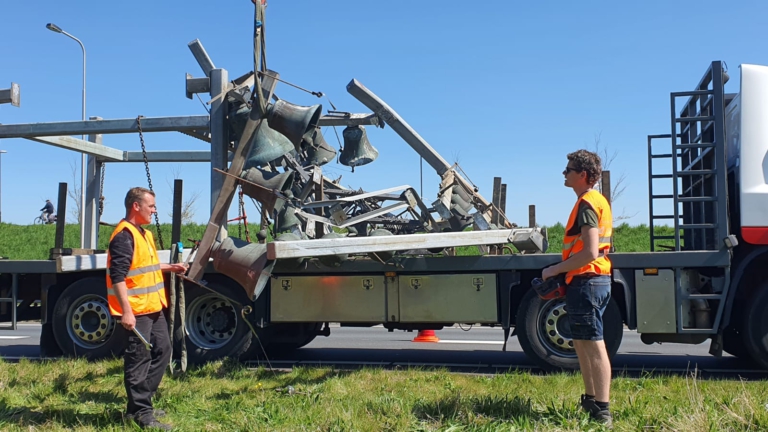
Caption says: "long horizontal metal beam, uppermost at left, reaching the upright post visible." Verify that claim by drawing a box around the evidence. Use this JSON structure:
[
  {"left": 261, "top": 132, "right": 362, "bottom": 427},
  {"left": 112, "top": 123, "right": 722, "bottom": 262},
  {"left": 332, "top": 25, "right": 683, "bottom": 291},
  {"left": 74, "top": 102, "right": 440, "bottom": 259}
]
[{"left": 0, "top": 115, "right": 210, "bottom": 138}]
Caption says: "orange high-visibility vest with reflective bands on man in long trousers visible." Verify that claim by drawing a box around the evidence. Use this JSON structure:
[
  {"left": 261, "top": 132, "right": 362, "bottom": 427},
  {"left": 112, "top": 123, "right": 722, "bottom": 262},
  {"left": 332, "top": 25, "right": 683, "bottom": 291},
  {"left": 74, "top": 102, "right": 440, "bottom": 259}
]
[{"left": 107, "top": 219, "right": 168, "bottom": 316}]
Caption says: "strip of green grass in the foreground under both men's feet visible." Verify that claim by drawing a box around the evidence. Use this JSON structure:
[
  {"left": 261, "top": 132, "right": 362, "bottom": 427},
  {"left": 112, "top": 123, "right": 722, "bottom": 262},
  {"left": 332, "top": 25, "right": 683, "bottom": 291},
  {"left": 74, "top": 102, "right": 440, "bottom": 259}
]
[{"left": 0, "top": 360, "right": 768, "bottom": 431}]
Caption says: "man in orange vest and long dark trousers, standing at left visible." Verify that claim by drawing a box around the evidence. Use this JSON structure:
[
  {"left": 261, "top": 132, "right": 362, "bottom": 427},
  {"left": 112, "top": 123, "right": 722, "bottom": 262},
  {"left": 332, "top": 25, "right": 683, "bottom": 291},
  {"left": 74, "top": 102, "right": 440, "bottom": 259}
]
[{"left": 107, "top": 187, "right": 187, "bottom": 430}]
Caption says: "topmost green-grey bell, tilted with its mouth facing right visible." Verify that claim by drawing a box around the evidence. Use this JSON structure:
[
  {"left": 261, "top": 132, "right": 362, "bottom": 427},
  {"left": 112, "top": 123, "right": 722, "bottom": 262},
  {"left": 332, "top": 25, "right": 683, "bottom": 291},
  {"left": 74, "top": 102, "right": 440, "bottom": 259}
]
[{"left": 267, "top": 99, "right": 323, "bottom": 151}]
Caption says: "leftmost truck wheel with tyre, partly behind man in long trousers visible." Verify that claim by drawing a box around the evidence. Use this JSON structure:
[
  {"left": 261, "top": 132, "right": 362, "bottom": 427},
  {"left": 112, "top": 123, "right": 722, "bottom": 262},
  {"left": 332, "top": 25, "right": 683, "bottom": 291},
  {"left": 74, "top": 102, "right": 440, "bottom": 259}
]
[{"left": 52, "top": 277, "right": 127, "bottom": 360}]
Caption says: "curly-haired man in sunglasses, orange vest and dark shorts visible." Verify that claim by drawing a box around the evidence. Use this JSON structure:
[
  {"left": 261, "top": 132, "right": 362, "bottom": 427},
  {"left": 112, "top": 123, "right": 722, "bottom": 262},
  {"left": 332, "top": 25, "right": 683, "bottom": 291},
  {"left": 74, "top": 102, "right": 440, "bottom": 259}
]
[{"left": 542, "top": 150, "right": 613, "bottom": 425}]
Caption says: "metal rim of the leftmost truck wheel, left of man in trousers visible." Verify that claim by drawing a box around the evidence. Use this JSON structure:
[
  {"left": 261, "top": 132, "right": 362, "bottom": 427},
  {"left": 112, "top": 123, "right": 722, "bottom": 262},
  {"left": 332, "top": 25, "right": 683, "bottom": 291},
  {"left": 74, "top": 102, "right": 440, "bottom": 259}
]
[{"left": 67, "top": 294, "right": 116, "bottom": 349}]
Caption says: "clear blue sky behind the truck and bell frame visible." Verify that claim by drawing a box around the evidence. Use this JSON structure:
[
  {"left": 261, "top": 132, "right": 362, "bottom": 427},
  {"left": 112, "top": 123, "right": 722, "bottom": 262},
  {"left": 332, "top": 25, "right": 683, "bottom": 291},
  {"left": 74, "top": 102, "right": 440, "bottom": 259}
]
[{"left": 0, "top": 0, "right": 768, "bottom": 225}]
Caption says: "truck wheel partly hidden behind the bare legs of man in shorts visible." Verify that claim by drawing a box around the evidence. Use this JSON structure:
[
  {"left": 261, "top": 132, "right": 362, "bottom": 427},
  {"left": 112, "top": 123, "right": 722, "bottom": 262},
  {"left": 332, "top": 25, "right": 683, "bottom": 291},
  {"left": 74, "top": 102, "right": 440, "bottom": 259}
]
[{"left": 516, "top": 290, "right": 624, "bottom": 371}]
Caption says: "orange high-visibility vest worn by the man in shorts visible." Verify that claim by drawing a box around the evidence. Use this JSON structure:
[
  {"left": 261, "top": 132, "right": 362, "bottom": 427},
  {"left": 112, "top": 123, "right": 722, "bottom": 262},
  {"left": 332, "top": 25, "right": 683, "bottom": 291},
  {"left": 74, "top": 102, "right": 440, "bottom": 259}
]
[{"left": 563, "top": 189, "right": 613, "bottom": 284}]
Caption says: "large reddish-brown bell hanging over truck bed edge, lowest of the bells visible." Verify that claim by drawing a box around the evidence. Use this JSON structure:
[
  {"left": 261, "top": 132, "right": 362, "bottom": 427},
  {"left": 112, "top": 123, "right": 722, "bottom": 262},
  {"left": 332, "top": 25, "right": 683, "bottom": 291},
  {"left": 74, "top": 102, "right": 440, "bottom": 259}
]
[{"left": 211, "top": 237, "right": 267, "bottom": 299}]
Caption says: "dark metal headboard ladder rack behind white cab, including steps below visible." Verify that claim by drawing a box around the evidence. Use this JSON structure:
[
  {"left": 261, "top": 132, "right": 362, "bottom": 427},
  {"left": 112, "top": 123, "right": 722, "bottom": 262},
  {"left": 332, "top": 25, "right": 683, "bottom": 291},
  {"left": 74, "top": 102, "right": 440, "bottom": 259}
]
[{"left": 648, "top": 61, "right": 730, "bottom": 334}]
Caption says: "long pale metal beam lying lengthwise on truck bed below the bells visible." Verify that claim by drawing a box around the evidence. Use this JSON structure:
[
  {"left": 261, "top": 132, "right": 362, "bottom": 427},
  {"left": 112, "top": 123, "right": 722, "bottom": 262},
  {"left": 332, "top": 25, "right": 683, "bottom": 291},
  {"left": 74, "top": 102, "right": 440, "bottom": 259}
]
[{"left": 267, "top": 228, "right": 531, "bottom": 260}]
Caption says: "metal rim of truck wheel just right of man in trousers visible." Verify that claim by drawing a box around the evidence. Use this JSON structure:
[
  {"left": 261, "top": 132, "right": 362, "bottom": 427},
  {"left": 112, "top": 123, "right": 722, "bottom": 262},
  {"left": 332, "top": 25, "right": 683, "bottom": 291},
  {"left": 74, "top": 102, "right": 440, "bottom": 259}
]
[{"left": 186, "top": 294, "right": 237, "bottom": 349}]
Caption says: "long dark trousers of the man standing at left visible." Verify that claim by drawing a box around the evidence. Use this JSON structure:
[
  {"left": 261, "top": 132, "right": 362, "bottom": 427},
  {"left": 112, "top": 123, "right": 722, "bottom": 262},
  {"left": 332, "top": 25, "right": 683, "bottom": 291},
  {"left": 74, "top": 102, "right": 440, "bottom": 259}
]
[{"left": 123, "top": 312, "right": 171, "bottom": 421}]
